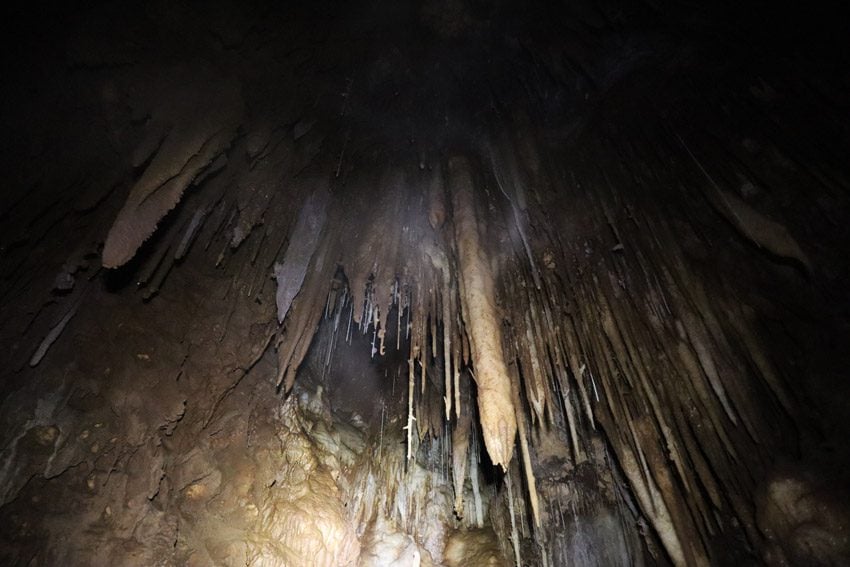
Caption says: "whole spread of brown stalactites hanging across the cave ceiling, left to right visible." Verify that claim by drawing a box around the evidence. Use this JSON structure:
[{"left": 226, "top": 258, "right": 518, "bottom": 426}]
[{"left": 94, "top": 103, "right": 810, "bottom": 563}]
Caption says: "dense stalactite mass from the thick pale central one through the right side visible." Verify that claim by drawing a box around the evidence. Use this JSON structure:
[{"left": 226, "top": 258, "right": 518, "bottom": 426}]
[{"left": 266, "top": 134, "right": 793, "bottom": 564}]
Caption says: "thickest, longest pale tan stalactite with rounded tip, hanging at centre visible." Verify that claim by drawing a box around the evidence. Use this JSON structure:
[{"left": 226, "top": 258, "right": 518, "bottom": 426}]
[{"left": 448, "top": 157, "right": 517, "bottom": 468}]
